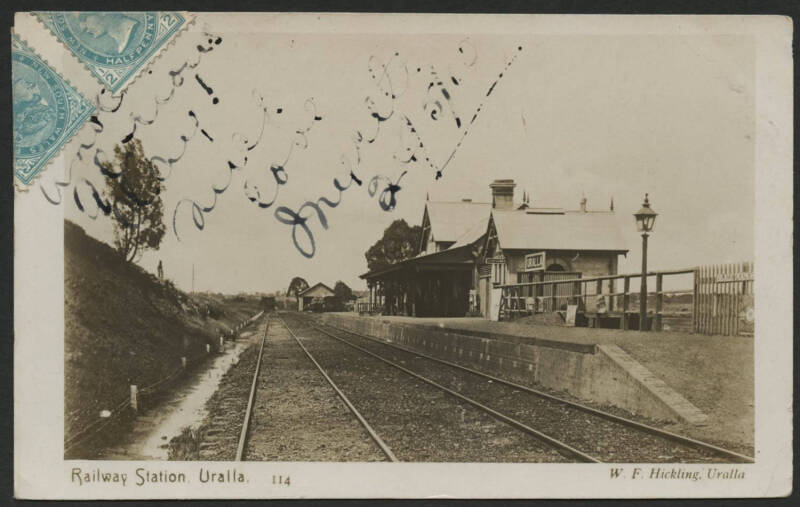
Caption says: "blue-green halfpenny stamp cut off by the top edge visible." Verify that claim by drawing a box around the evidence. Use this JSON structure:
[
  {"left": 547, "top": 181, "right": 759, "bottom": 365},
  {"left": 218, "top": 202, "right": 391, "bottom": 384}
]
[{"left": 36, "top": 11, "right": 188, "bottom": 94}]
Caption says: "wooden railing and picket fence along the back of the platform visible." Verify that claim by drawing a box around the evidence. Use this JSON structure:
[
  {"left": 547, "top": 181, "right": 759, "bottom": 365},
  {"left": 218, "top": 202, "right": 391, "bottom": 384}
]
[{"left": 496, "top": 262, "right": 754, "bottom": 335}]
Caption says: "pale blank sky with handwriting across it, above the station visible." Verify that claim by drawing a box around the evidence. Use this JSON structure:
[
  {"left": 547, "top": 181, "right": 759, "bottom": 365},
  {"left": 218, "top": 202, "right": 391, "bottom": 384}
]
[{"left": 59, "top": 14, "right": 755, "bottom": 293}]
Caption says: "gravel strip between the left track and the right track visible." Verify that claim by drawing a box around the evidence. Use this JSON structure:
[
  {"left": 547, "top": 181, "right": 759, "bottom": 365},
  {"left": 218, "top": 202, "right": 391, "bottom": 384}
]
[{"left": 286, "top": 316, "right": 567, "bottom": 462}]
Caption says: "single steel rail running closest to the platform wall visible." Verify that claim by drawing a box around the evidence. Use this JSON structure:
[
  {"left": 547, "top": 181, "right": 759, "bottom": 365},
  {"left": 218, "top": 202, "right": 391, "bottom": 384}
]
[{"left": 314, "top": 324, "right": 755, "bottom": 463}]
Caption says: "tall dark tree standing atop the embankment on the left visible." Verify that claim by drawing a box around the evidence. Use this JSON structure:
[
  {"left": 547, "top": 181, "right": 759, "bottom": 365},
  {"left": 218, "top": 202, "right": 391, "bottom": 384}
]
[{"left": 102, "top": 139, "right": 166, "bottom": 262}]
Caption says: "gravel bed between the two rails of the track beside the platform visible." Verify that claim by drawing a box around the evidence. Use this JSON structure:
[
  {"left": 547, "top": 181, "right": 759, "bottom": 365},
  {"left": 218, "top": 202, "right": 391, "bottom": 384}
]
[{"left": 314, "top": 322, "right": 744, "bottom": 463}]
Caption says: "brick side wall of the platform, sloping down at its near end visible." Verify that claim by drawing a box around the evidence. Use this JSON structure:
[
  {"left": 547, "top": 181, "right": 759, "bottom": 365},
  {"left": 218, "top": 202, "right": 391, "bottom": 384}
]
[{"left": 321, "top": 314, "right": 707, "bottom": 425}]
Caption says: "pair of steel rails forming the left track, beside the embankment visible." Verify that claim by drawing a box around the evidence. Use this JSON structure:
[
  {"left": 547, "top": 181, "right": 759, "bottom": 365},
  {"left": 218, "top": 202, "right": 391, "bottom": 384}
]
[{"left": 235, "top": 315, "right": 398, "bottom": 462}]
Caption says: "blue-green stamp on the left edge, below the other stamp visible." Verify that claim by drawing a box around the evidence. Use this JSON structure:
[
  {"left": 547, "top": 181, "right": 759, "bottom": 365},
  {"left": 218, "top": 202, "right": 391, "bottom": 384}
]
[{"left": 11, "top": 35, "right": 95, "bottom": 189}]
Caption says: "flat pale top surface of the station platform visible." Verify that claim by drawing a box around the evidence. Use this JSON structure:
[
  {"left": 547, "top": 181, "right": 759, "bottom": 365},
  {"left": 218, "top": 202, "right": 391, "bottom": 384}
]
[{"left": 328, "top": 313, "right": 755, "bottom": 446}]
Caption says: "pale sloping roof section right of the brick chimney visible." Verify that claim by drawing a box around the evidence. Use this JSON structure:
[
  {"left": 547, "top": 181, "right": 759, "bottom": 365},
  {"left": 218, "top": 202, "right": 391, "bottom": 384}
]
[{"left": 492, "top": 210, "right": 628, "bottom": 252}]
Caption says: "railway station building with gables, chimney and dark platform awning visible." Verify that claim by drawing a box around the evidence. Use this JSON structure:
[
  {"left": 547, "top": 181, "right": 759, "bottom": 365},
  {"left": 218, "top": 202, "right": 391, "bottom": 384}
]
[{"left": 361, "top": 180, "right": 628, "bottom": 320}]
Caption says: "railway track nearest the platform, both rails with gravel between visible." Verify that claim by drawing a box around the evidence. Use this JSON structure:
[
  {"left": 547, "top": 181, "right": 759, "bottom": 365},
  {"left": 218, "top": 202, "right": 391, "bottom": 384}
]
[{"left": 294, "top": 314, "right": 754, "bottom": 463}]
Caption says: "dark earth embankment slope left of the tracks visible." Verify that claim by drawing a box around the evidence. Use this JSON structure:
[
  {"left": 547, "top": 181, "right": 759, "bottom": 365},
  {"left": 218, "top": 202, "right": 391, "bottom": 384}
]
[{"left": 64, "top": 221, "right": 258, "bottom": 448}]
